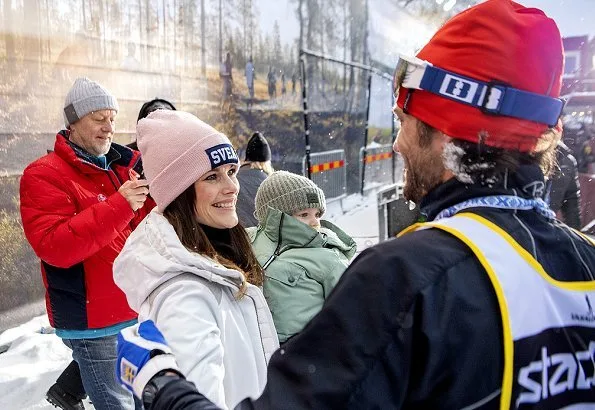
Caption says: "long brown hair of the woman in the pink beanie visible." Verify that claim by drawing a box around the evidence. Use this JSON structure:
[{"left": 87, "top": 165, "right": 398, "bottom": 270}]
[{"left": 163, "top": 185, "right": 264, "bottom": 297}]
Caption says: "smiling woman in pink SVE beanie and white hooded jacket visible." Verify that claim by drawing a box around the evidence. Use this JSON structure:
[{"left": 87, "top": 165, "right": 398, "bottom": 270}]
[{"left": 114, "top": 110, "right": 279, "bottom": 409}]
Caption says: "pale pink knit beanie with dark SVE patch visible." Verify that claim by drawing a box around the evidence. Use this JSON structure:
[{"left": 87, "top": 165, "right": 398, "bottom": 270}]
[{"left": 136, "top": 110, "right": 239, "bottom": 212}]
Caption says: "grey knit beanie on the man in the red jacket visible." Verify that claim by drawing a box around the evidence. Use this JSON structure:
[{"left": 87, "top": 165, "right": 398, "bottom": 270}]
[{"left": 64, "top": 77, "right": 119, "bottom": 127}]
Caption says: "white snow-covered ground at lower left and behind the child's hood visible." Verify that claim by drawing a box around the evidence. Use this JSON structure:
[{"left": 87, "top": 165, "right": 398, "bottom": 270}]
[{"left": 0, "top": 194, "right": 378, "bottom": 410}]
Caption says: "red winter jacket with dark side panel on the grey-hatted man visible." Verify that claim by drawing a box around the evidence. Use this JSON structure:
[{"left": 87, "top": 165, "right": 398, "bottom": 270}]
[{"left": 20, "top": 131, "right": 155, "bottom": 330}]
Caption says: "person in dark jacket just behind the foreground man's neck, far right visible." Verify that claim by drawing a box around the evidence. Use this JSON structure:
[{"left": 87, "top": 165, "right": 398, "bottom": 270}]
[{"left": 547, "top": 141, "right": 581, "bottom": 229}]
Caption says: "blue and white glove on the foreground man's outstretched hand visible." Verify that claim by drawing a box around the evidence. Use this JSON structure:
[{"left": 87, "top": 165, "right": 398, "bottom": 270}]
[{"left": 116, "top": 320, "right": 182, "bottom": 399}]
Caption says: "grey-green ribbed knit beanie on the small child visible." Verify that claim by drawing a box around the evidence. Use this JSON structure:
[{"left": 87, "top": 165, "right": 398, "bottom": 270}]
[{"left": 254, "top": 171, "right": 326, "bottom": 222}]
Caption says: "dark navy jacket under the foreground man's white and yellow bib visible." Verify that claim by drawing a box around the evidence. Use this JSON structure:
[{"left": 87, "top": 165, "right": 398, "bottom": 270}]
[{"left": 153, "top": 166, "right": 595, "bottom": 410}]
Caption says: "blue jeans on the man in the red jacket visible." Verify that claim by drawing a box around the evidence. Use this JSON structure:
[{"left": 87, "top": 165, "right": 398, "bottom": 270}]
[{"left": 62, "top": 335, "right": 141, "bottom": 410}]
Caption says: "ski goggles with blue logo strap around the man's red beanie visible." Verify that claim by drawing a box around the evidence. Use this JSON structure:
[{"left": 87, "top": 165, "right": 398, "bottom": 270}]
[{"left": 393, "top": 56, "right": 564, "bottom": 127}]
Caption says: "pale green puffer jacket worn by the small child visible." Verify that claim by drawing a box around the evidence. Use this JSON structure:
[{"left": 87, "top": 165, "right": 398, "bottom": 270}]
[{"left": 249, "top": 208, "right": 356, "bottom": 342}]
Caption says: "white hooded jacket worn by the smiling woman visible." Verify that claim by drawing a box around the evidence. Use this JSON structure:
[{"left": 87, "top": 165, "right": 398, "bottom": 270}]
[{"left": 114, "top": 209, "right": 279, "bottom": 409}]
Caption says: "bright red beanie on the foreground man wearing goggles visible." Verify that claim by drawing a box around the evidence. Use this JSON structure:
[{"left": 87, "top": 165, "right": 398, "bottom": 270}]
[{"left": 397, "top": 0, "right": 564, "bottom": 152}]
